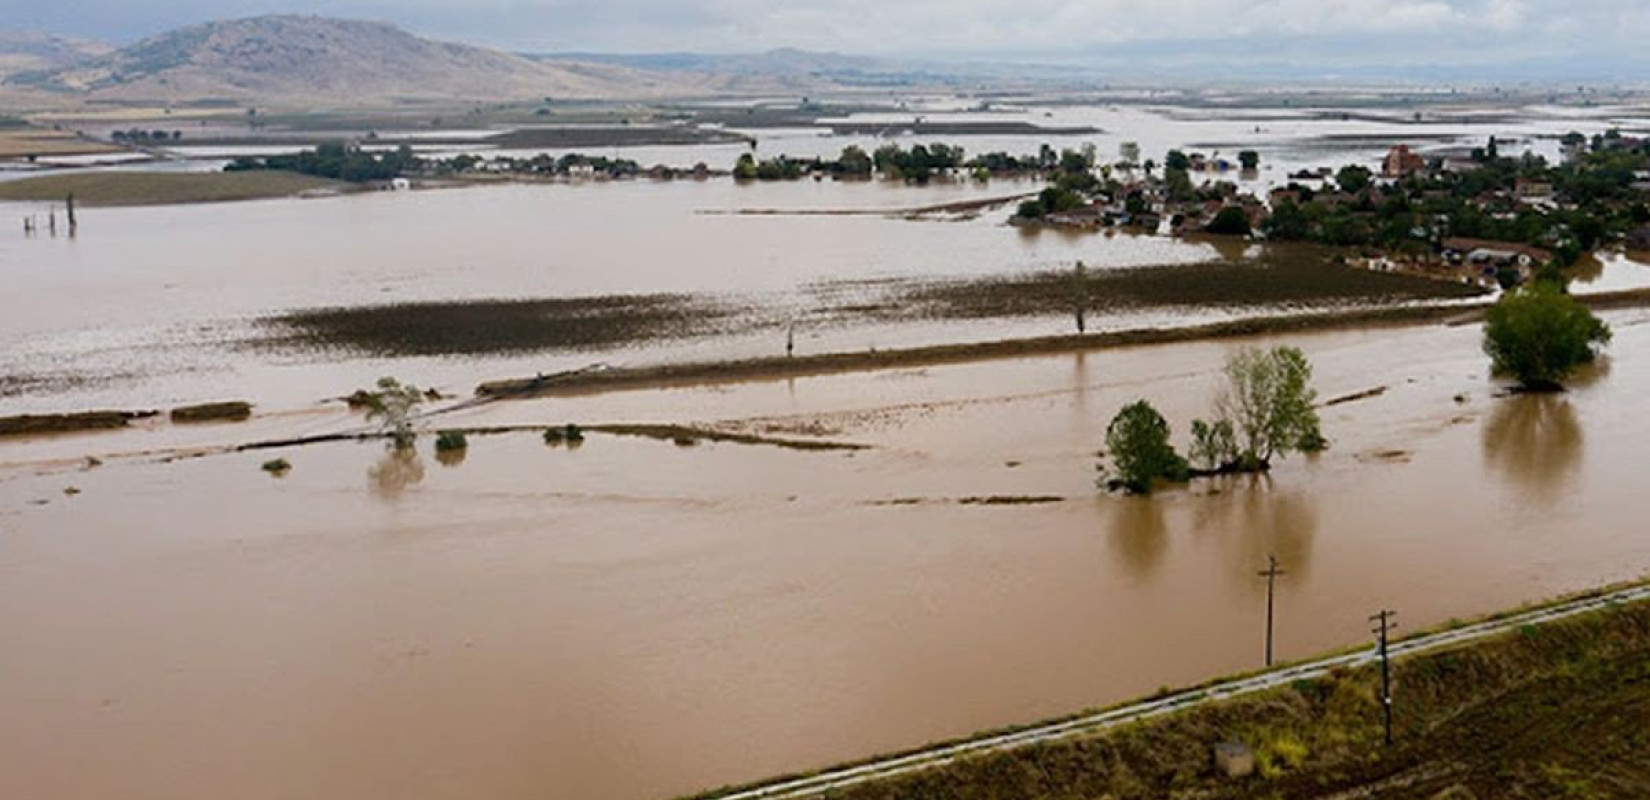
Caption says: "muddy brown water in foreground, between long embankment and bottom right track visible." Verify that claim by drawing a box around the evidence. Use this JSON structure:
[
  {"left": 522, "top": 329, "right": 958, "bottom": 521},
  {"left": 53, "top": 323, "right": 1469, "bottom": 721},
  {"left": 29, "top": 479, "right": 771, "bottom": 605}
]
[{"left": 0, "top": 312, "right": 1650, "bottom": 800}]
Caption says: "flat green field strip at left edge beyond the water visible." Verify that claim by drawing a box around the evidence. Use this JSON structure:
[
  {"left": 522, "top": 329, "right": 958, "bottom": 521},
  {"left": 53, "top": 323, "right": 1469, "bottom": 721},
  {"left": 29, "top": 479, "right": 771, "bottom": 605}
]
[{"left": 0, "top": 172, "right": 342, "bottom": 206}]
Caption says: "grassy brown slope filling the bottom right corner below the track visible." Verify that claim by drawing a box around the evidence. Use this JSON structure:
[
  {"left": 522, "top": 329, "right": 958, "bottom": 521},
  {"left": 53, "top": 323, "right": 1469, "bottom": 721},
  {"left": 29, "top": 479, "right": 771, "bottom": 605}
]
[{"left": 755, "top": 604, "right": 1650, "bottom": 800}]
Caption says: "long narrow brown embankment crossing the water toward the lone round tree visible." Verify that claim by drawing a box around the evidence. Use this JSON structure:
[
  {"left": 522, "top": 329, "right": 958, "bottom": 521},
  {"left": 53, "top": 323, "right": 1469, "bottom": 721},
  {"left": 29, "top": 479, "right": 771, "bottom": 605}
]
[{"left": 475, "top": 289, "right": 1650, "bottom": 399}]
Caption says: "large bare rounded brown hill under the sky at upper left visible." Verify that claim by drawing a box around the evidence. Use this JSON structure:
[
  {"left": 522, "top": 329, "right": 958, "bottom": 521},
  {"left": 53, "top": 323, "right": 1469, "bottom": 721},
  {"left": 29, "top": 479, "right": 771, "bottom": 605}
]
[{"left": 7, "top": 15, "right": 673, "bottom": 106}]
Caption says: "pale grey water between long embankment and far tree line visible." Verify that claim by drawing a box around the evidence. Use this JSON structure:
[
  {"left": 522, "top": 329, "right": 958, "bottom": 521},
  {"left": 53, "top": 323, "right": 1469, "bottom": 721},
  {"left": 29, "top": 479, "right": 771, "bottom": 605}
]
[{"left": 0, "top": 180, "right": 1219, "bottom": 414}]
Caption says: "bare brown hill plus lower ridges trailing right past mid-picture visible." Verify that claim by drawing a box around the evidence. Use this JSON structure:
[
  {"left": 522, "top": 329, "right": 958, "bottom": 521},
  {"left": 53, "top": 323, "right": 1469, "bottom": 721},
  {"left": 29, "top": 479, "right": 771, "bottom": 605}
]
[{"left": 0, "top": 15, "right": 983, "bottom": 106}]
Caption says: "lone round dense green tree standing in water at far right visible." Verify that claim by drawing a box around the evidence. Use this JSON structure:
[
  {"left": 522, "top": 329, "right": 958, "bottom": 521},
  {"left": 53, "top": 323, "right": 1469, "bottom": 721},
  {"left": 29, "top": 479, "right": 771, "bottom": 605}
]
[{"left": 1483, "top": 280, "right": 1610, "bottom": 391}]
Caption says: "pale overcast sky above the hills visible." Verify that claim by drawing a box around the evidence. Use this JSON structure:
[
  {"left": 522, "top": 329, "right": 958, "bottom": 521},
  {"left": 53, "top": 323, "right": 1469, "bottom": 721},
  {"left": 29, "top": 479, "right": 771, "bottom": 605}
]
[{"left": 0, "top": 0, "right": 1650, "bottom": 78}]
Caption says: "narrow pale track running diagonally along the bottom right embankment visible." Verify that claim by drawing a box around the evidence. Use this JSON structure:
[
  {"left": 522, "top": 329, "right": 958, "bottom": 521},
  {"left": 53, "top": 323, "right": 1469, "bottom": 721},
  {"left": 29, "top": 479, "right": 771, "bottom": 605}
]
[{"left": 713, "top": 586, "right": 1650, "bottom": 800}]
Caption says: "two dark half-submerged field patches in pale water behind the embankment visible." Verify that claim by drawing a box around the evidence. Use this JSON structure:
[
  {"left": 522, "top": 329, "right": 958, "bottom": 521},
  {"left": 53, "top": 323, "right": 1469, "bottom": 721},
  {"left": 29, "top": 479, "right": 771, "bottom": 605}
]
[{"left": 254, "top": 251, "right": 1485, "bottom": 366}]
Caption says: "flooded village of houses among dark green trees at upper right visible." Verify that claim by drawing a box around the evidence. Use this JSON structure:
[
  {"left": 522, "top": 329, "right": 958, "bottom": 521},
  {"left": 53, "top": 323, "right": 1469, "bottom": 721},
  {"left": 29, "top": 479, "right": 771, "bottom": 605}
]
[{"left": 1013, "top": 132, "right": 1650, "bottom": 289}]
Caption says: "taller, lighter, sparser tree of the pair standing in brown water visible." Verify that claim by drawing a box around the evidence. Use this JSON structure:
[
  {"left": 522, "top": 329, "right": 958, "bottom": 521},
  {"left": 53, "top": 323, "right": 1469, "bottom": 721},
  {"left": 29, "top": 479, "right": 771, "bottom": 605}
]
[{"left": 1214, "top": 346, "right": 1325, "bottom": 472}]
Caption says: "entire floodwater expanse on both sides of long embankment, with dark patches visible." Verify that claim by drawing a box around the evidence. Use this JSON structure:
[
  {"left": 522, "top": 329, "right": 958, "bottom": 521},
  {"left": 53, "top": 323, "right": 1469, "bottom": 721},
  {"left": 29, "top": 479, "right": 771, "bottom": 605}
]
[{"left": 0, "top": 98, "right": 1650, "bottom": 800}]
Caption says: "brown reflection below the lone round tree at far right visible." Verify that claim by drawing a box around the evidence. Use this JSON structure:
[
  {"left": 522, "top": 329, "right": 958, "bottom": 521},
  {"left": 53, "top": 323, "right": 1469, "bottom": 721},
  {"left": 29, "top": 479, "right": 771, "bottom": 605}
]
[{"left": 1483, "top": 394, "right": 1584, "bottom": 505}]
